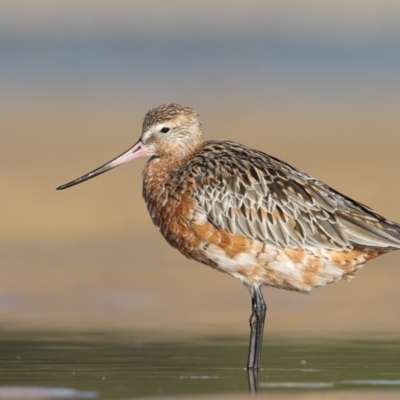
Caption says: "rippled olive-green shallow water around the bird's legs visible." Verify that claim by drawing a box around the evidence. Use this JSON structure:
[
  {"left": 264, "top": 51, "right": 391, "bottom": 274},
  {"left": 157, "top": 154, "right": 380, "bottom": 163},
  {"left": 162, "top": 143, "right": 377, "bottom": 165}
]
[{"left": 0, "top": 335, "right": 400, "bottom": 399}]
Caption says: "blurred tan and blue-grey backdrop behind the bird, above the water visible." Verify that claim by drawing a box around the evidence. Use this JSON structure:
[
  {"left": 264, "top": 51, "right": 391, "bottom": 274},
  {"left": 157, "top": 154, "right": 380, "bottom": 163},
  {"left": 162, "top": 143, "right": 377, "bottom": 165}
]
[{"left": 0, "top": 0, "right": 400, "bottom": 336}]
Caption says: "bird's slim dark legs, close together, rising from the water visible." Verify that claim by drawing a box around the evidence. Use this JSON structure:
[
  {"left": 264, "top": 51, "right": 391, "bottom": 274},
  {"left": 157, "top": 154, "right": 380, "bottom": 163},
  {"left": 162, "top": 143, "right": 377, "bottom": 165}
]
[{"left": 247, "top": 286, "right": 267, "bottom": 370}]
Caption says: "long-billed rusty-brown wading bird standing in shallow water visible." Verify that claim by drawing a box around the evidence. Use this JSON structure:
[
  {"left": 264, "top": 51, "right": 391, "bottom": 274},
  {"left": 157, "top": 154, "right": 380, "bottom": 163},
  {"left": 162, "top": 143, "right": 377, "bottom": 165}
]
[{"left": 57, "top": 103, "right": 400, "bottom": 371}]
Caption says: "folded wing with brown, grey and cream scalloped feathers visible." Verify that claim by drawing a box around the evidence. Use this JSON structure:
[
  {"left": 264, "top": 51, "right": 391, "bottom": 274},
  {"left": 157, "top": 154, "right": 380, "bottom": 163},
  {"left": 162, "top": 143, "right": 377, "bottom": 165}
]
[{"left": 185, "top": 141, "right": 400, "bottom": 250}]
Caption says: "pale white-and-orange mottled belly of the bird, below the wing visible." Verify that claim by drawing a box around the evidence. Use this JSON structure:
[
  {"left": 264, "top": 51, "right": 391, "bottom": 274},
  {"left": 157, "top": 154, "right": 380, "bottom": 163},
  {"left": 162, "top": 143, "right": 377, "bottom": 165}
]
[{"left": 204, "top": 242, "right": 381, "bottom": 292}]
